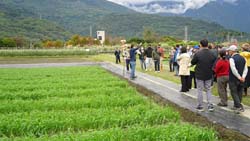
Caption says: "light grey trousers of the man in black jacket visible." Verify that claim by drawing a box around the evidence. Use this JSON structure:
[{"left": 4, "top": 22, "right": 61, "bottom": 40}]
[{"left": 196, "top": 79, "right": 212, "bottom": 106}]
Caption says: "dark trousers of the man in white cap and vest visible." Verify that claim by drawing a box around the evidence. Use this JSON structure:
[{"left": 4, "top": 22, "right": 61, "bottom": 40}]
[{"left": 229, "top": 81, "right": 244, "bottom": 108}]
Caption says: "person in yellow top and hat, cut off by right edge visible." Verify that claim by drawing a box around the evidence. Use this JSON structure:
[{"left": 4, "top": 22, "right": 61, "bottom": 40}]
[{"left": 240, "top": 43, "right": 250, "bottom": 96}]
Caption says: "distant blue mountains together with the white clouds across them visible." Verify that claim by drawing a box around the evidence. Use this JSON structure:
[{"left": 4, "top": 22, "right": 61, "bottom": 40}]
[{"left": 111, "top": 0, "right": 250, "bottom": 32}]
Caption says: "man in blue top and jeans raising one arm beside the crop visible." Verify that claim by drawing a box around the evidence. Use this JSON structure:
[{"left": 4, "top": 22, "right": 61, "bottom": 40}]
[{"left": 129, "top": 44, "right": 139, "bottom": 80}]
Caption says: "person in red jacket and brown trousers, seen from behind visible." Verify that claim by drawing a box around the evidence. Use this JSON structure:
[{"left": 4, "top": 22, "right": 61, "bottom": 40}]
[{"left": 214, "top": 50, "right": 230, "bottom": 107}]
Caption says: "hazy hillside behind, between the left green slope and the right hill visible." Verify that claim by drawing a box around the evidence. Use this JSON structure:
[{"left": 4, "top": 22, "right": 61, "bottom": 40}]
[{"left": 2, "top": 0, "right": 133, "bottom": 35}]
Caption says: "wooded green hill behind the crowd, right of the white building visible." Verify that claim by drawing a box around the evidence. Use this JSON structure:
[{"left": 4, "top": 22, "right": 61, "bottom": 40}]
[{"left": 97, "top": 14, "right": 230, "bottom": 40}]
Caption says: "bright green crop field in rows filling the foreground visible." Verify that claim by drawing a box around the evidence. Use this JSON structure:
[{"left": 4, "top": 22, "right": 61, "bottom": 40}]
[{"left": 0, "top": 67, "right": 217, "bottom": 141}]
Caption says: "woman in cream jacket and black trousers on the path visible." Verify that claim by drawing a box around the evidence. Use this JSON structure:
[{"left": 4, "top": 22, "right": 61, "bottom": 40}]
[{"left": 177, "top": 47, "right": 191, "bottom": 92}]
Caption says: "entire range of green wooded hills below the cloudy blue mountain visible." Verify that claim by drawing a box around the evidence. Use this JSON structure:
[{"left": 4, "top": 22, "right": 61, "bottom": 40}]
[{"left": 0, "top": 0, "right": 247, "bottom": 40}]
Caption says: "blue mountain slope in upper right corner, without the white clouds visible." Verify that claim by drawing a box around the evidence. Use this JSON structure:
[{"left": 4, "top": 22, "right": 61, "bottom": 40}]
[{"left": 183, "top": 0, "right": 250, "bottom": 33}]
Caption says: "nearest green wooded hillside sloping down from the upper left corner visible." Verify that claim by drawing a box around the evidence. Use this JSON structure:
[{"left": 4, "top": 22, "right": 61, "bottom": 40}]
[{"left": 0, "top": 1, "right": 72, "bottom": 40}]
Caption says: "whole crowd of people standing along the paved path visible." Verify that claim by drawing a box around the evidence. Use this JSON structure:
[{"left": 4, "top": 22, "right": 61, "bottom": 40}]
[{"left": 115, "top": 39, "right": 250, "bottom": 113}]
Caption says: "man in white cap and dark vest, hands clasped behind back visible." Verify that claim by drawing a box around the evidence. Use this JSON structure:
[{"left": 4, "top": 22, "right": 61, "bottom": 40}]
[{"left": 227, "top": 45, "right": 248, "bottom": 114}]
